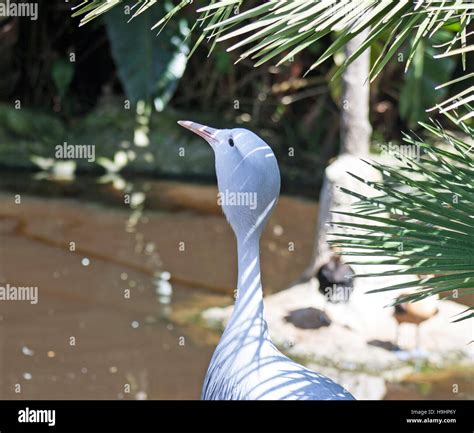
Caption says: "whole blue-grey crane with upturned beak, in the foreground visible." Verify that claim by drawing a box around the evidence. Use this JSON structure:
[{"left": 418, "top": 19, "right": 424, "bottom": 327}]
[{"left": 178, "top": 121, "right": 354, "bottom": 400}]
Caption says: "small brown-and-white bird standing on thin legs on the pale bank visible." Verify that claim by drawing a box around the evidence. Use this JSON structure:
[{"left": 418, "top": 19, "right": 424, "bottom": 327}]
[{"left": 393, "top": 294, "right": 439, "bottom": 350}]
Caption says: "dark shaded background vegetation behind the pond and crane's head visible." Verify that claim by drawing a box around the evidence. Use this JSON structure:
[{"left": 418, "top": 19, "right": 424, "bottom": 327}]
[{"left": 0, "top": 0, "right": 468, "bottom": 191}]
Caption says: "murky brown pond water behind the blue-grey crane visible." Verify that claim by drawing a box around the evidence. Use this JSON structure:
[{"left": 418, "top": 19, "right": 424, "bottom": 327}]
[{"left": 0, "top": 172, "right": 467, "bottom": 399}]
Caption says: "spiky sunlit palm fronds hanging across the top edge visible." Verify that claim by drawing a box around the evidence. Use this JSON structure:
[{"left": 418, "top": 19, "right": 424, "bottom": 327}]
[{"left": 74, "top": 0, "right": 474, "bottom": 121}]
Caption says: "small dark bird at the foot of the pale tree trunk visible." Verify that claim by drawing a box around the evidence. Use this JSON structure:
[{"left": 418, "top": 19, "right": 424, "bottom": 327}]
[{"left": 316, "top": 255, "right": 354, "bottom": 303}]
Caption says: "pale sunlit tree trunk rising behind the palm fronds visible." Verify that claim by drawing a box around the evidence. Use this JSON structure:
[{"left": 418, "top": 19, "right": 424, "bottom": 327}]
[{"left": 302, "top": 29, "right": 373, "bottom": 280}]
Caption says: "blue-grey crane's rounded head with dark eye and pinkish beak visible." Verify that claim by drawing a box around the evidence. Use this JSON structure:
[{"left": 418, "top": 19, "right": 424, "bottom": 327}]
[{"left": 178, "top": 121, "right": 280, "bottom": 240}]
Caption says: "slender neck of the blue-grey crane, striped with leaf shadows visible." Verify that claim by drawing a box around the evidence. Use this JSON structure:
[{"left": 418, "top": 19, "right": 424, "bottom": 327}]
[{"left": 229, "top": 234, "right": 267, "bottom": 337}]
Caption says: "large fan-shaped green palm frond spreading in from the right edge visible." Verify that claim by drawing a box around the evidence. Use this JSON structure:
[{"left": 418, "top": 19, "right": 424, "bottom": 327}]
[{"left": 330, "top": 115, "right": 474, "bottom": 320}]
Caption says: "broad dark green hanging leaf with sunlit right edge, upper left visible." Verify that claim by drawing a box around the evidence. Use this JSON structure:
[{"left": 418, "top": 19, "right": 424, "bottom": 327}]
[{"left": 105, "top": 1, "right": 189, "bottom": 111}]
